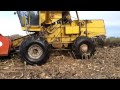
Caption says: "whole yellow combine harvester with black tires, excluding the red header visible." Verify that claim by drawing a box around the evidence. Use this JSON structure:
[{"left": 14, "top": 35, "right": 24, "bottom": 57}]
[{"left": 1, "top": 11, "right": 106, "bottom": 65}]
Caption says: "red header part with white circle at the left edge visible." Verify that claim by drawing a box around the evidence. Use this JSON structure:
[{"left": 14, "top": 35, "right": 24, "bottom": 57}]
[{"left": 0, "top": 34, "right": 12, "bottom": 56}]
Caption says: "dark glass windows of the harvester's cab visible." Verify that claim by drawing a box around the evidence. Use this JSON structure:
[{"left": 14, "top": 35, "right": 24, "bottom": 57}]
[{"left": 17, "top": 11, "right": 39, "bottom": 26}]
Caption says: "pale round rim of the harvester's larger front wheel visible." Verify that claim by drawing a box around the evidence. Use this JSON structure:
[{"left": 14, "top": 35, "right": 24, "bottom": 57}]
[{"left": 28, "top": 44, "right": 43, "bottom": 59}]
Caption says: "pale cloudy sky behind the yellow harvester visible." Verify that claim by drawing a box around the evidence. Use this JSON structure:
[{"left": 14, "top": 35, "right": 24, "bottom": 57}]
[{"left": 0, "top": 11, "right": 120, "bottom": 37}]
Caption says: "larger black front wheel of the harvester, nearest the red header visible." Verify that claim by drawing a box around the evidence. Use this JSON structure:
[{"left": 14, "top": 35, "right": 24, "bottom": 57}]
[{"left": 20, "top": 36, "right": 49, "bottom": 65}]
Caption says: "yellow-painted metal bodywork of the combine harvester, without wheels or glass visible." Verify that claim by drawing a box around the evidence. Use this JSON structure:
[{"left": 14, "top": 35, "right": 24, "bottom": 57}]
[{"left": 19, "top": 11, "right": 106, "bottom": 47}]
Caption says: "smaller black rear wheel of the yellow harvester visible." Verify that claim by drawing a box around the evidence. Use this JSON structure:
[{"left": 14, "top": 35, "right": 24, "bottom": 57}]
[{"left": 73, "top": 37, "right": 95, "bottom": 59}]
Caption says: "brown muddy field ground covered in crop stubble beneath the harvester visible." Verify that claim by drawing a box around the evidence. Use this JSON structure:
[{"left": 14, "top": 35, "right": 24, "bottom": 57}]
[{"left": 0, "top": 47, "right": 120, "bottom": 79}]
